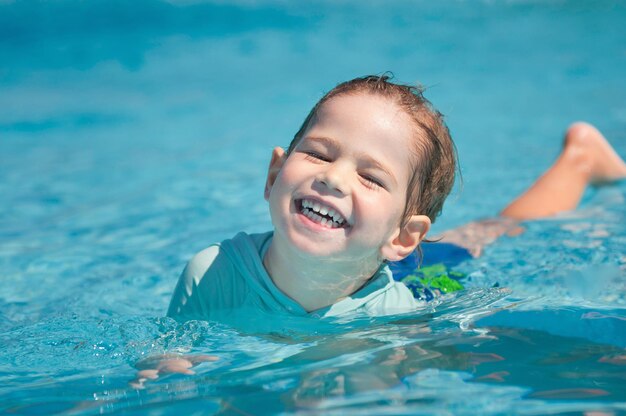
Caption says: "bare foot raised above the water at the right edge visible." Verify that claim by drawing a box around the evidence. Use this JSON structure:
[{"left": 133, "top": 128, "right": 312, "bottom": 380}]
[{"left": 563, "top": 122, "right": 626, "bottom": 185}]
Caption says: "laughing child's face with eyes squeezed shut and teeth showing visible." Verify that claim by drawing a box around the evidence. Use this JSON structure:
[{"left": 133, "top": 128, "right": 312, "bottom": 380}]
[{"left": 266, "top": 93, "right": 429, "bottom": 263}]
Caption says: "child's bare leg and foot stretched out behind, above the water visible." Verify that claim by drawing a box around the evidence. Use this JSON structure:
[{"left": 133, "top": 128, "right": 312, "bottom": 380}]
[{"left": 434, "top": 123, "right": 626, "bottom": 257}]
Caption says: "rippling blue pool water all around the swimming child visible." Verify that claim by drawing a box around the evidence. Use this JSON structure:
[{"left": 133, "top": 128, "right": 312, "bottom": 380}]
[{"left": 0, "top": 0, "right": 626, "bottom": 415}]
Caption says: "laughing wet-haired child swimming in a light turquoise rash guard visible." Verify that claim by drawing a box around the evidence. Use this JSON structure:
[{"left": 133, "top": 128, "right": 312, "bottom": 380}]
[{"left": 168, "top": 76, "right": 626, "bottom": 326}]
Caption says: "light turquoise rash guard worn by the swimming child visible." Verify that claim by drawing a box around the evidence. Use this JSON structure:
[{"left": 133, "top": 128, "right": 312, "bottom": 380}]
[{"left": 167, "top": 232, "right": 424, "bottom": 323}]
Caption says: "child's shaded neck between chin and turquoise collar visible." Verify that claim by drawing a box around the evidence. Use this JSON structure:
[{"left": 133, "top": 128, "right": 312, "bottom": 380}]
[{"left": 263, "top": 238, "right": 380, "bottom": 312}]
